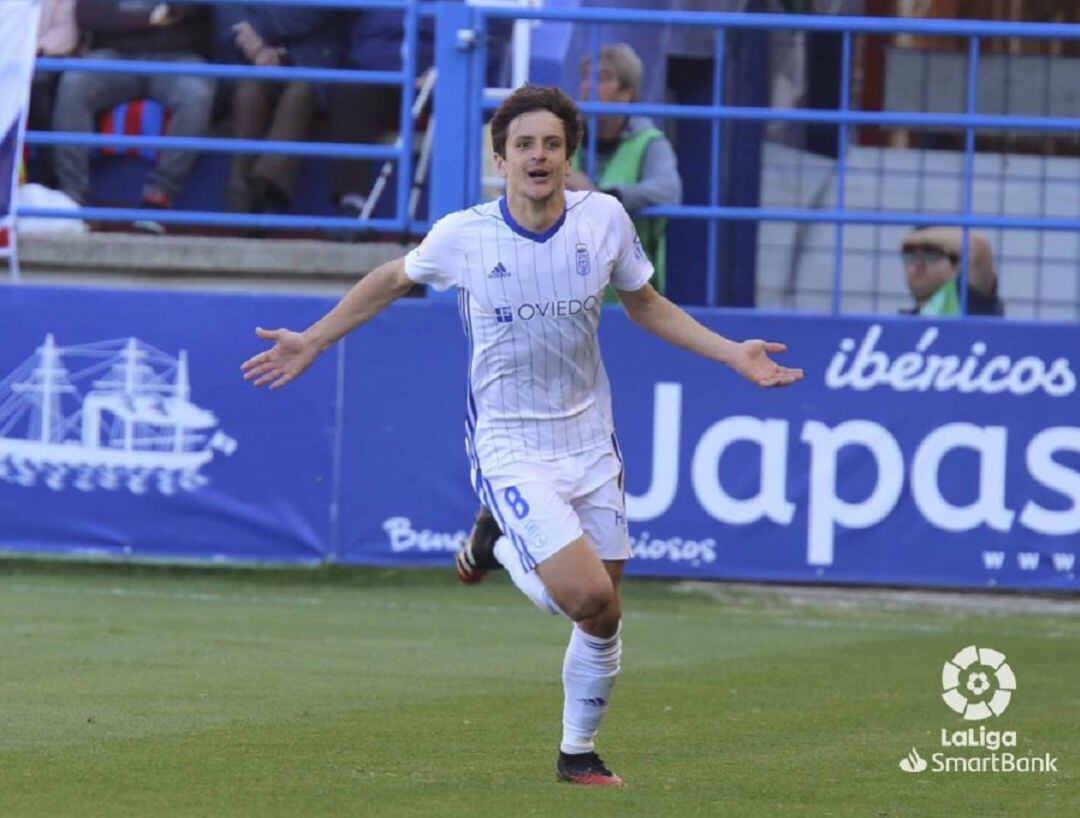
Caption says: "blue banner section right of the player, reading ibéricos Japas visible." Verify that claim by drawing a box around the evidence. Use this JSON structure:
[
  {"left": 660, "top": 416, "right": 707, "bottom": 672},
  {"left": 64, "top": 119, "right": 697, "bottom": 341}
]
[{"left": 608, "top": 312, "right": 1080, "bottom": 588}]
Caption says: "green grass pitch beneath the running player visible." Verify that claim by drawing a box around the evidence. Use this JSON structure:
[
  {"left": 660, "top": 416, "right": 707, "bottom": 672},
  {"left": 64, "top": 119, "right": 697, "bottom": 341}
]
[{"left": 0, "top": 562, "right": 1080, "bottom": 818}]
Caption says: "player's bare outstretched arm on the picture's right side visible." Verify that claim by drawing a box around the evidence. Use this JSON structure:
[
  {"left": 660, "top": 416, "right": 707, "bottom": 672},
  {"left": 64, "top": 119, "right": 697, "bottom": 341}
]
[{"left": 617, "top": 284, "right": 802, "bottom": 387}]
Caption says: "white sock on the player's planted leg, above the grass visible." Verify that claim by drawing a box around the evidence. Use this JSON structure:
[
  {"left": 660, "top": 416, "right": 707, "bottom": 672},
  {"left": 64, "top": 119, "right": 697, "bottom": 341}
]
[{"left": 559, "top": 623, "right": 622, "bottom": 753}]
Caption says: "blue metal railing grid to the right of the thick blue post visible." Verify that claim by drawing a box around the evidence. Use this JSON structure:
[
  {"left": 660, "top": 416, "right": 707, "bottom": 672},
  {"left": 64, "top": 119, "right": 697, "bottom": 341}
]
[{"left": 472, "top": 8, "right": 1080, "bottom": 313}]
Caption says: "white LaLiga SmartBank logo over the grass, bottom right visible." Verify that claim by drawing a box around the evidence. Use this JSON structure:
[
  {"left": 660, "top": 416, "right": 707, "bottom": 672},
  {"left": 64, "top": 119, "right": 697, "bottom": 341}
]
[{"left": 900, "top": 645, "right": 1057, "bottom": 773}]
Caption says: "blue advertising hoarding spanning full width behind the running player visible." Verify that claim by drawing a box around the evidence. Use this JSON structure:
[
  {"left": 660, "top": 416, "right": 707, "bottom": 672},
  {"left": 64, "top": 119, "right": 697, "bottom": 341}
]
[{"left": 0, "top": 287, "right": 1080, "bottom": 590}]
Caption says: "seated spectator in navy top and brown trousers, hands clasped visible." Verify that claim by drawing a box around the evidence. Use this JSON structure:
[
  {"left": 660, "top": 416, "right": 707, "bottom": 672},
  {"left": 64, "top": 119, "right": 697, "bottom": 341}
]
[{"left": 214, "top": 3, "right": 345, "bottom": 213}]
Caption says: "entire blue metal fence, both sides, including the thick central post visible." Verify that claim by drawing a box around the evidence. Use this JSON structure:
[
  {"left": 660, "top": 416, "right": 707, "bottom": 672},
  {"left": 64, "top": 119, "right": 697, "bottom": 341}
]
[{"left": 21, "top": 0, "right": 1080, "bottom": 312}]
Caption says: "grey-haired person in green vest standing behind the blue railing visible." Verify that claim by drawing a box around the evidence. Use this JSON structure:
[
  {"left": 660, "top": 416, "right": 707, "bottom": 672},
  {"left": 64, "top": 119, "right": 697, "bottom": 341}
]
[{"left": 566, "top": 43, "right": 683, "bottom": 293}]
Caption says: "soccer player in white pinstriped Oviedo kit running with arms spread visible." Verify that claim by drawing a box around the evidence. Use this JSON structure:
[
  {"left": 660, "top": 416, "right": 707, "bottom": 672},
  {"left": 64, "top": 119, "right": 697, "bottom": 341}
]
[{"left": 243, "top": 85, "right": 802, "bottom": 786}]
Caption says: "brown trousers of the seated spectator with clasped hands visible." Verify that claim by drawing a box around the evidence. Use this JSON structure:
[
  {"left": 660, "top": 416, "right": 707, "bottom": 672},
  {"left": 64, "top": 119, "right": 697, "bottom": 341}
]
[{"left": 228, "top": 80, "right": 315, "bottom": 212}]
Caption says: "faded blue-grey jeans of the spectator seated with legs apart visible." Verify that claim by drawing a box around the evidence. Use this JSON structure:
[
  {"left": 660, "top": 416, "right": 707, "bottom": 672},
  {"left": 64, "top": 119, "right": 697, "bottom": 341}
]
[{"left": 53, "top": 49, "right": 215, "bottom": 203}]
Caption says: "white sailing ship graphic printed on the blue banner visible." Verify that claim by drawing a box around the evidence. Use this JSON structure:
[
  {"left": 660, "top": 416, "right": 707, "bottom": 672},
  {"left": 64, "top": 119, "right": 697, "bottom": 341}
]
[{"left": 0, "top": 334, "right": 237, "bottom": 495}]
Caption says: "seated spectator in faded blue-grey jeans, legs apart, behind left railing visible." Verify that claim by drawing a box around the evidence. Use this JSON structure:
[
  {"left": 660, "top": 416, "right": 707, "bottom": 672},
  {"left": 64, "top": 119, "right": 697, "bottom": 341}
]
[{"left": 53, "top": 0, "right": 215, "bottom": 233}]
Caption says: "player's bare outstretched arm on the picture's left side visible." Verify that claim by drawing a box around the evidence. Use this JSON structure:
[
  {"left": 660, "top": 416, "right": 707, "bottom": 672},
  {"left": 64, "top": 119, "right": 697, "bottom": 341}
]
[{"left": 240, "top": 258, "right": 413, "bottom": 389}]
